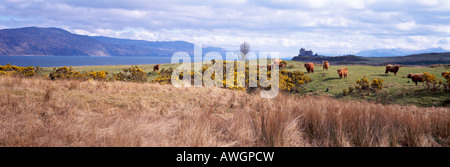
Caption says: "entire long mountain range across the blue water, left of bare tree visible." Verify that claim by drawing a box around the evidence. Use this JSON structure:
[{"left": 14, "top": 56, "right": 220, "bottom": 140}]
[{"left": 0, "top": 27, "right": 226, "bottom": 57}]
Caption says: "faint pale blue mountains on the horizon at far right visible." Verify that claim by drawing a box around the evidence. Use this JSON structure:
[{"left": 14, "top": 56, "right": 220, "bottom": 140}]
[{"left": 355, "top": 47, "right": 450, "bottom": 57}]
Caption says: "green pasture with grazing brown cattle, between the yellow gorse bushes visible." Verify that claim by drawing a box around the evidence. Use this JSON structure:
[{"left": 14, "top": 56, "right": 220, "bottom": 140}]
[{"left": 43, "top": 61, "right": 450, "bottom": 107}]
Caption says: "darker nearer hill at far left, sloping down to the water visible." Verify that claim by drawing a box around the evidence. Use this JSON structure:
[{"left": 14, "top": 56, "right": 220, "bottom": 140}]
[{"left": 0, "top": 27, "right": 111, "bottom": 56}]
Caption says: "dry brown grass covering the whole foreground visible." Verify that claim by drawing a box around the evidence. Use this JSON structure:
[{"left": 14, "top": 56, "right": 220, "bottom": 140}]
[{"left": 0, "top": 77, "right": 450, "bottom": 147}]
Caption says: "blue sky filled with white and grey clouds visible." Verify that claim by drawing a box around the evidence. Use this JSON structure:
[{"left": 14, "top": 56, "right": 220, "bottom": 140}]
[{"left": 0, "top": 0, "right": 450, "bottom": 57}]
